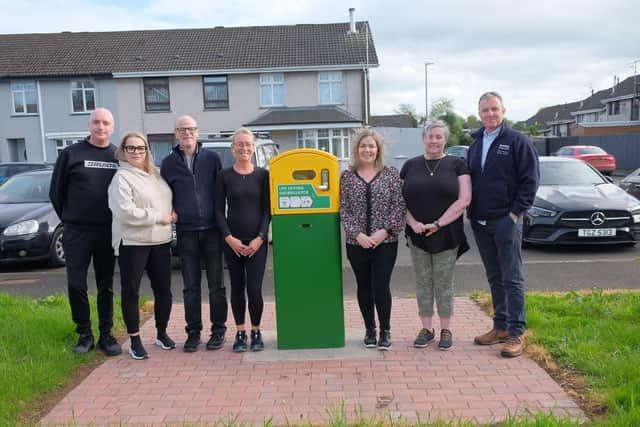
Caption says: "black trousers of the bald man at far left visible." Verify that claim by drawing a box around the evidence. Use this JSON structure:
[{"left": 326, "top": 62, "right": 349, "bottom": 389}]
[{"left": 62, "top": 223, "right": 116, "bottom": 335}]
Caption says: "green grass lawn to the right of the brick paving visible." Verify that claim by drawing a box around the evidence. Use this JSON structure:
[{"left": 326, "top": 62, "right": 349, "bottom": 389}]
[{"left": 527, "top": 290, "right": 640, "bottom": 426}]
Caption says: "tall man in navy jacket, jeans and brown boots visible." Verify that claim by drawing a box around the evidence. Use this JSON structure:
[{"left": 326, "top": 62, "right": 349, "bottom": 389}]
[{"left": 468, "top": 92, "right": 540, "bottom": 357}]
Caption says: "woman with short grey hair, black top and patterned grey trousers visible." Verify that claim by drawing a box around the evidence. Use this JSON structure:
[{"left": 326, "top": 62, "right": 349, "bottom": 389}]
[{"left": 400, "top": 120, "right": 471, "bottom": 350}]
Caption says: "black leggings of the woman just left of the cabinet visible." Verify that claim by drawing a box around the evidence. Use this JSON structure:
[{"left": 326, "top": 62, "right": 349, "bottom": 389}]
[{"left": 224, "top": 241, "right": 269, "bottom": 326}]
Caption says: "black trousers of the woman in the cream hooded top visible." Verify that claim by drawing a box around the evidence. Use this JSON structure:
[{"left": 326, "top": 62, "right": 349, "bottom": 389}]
[{"left": 118, "top": 243, "right": 172, "bottom": 334}]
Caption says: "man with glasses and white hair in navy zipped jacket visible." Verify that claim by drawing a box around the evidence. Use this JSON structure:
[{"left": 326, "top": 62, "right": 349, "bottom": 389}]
[{"left": 160, "top": 116, "right": 227, "bottom": 352}]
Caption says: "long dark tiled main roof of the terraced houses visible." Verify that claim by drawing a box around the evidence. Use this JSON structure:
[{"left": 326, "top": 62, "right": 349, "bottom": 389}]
[{"left": 0, "top": 22, "right": 378, "bottom": 78}]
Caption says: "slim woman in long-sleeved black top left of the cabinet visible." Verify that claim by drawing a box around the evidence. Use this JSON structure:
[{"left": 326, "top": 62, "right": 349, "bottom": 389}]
[{"left": 216, "top": 128, "right": 271, "bottom": 352}]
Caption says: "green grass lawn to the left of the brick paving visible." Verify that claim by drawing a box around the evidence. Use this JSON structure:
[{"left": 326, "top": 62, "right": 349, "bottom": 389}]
[{"left": 0, "top": 293, "right": 123, "bottom": 426}]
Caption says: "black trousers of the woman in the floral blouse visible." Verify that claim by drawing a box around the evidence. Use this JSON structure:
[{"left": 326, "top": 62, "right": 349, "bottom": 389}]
[{"left": 347, "top": 242, "right": 398, "bottom": 331}]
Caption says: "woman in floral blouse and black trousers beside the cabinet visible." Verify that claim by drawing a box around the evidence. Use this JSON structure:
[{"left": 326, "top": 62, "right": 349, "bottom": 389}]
[{"left": 340, "top": 129, "right": 405, "bottom": 350}]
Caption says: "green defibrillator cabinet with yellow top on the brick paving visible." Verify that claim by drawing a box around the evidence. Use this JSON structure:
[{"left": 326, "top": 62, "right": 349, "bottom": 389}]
[{"left": 269, "top": 149, "right": 344, "bottom": 349}]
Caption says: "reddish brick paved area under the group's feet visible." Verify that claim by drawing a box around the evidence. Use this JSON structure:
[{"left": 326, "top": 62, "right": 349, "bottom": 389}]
[{"left": 42, "top": 298, "right": 584, "bottom": 425}]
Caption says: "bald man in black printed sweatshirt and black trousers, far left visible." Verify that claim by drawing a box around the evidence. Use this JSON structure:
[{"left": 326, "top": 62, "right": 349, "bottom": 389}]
[{"left": 49, "top": 108, "right": 122, "bottom": 356}]
